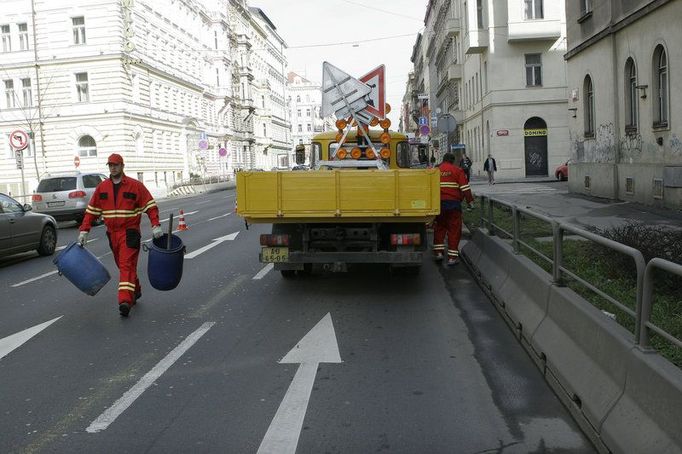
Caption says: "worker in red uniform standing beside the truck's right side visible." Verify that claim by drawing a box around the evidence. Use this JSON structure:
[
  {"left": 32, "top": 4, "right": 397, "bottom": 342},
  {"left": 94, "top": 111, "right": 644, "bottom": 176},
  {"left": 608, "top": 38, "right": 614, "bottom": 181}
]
[{"left": 433, "top": 153, "right": 474, "bottom": 266}]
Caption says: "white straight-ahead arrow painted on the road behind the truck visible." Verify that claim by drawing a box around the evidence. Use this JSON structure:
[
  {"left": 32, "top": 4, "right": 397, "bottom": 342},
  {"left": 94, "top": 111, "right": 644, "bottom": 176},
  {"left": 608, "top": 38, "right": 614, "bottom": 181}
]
[{"left": 258, "top": 314, "right": 342, "bottom": 454}]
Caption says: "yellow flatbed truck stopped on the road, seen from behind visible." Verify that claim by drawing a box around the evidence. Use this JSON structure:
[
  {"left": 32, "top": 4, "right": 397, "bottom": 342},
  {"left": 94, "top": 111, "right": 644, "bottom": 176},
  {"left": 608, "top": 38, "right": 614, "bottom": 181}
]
[{"left": 237, "top": 130, "right": 440, "bottom": 278}]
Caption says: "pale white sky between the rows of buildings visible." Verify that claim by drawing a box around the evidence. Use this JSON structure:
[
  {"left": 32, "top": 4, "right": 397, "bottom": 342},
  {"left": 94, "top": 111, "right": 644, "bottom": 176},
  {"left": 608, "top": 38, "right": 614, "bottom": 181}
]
[{"left": 249, "top": 0, "right": 428, "bottom": 124}]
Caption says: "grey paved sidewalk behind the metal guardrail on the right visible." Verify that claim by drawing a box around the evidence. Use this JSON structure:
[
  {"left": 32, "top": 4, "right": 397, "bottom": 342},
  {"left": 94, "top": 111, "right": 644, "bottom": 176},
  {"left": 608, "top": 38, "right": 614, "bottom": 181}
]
[{"left": 464, "top": 177, "right": 682, "bottom": 230}]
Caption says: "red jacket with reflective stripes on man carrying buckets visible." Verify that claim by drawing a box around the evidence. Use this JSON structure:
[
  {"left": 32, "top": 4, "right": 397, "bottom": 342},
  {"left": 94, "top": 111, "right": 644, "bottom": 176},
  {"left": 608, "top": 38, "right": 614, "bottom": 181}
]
[{"left": 80, "top": 175, "right": 159, "bottom": 232}]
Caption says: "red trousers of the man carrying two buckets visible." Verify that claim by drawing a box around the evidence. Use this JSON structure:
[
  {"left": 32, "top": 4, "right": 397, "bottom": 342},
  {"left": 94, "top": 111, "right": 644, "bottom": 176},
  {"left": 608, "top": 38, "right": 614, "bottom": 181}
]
[{"left": 107, "top": 229, "right": 142, "bottom": 306}]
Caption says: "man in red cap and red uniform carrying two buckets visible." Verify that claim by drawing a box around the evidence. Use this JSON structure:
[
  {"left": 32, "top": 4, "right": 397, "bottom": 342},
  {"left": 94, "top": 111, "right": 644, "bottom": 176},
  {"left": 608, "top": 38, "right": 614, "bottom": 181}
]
[{"left": 78, "top": 153, "right": 163, "bottom": 317}]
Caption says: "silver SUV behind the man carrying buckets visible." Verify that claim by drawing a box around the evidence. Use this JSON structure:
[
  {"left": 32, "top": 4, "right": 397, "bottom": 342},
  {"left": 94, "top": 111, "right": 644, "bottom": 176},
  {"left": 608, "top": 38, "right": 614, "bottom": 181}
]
[{"left": 31, "top": 172, "right": 107, "bottom": 224}]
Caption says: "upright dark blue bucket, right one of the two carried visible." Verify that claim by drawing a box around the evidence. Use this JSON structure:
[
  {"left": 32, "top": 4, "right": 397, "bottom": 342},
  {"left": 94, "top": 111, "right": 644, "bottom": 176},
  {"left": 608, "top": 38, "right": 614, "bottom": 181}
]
[{"left": 145, "top": 234, "right": 185, "bottom": 290}]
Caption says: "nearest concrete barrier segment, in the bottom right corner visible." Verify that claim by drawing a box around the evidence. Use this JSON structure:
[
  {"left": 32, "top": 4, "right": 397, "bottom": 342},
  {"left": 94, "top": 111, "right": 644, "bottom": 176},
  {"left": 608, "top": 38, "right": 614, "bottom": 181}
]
[{"left": 602, "top": 348, "right": 682, "bottom": 453}]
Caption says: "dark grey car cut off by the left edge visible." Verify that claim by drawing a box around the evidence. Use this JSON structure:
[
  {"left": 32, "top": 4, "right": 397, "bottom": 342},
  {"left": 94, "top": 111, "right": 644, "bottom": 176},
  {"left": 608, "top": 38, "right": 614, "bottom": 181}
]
[{"left": 0, "top": 194, "right": 57, "bottom": 257}]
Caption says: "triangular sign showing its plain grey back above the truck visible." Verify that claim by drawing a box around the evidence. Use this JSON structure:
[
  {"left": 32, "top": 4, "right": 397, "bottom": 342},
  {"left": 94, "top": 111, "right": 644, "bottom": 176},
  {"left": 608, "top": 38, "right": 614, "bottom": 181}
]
[{"left": 321, "top": 62, "right": 372, "bottom": 118}]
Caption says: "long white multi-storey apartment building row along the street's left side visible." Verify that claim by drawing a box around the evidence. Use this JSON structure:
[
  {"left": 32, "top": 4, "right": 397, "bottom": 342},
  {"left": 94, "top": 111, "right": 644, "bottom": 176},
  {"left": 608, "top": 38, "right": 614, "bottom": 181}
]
[{"left": 0, "top": 0, "right": 288, "bottom": 199}]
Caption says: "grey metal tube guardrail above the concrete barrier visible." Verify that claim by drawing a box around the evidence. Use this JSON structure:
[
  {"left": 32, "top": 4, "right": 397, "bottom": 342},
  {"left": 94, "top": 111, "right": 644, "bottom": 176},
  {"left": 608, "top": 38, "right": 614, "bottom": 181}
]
[{"left": 479, "top": 195, "right": 682, "bottom": 348}]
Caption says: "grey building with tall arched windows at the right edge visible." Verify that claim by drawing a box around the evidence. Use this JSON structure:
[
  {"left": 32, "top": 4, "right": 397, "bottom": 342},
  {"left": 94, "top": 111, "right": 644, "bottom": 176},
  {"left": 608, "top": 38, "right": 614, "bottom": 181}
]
[{"left": 566, "top": 0, "right": 682, "bottom": 209}]
